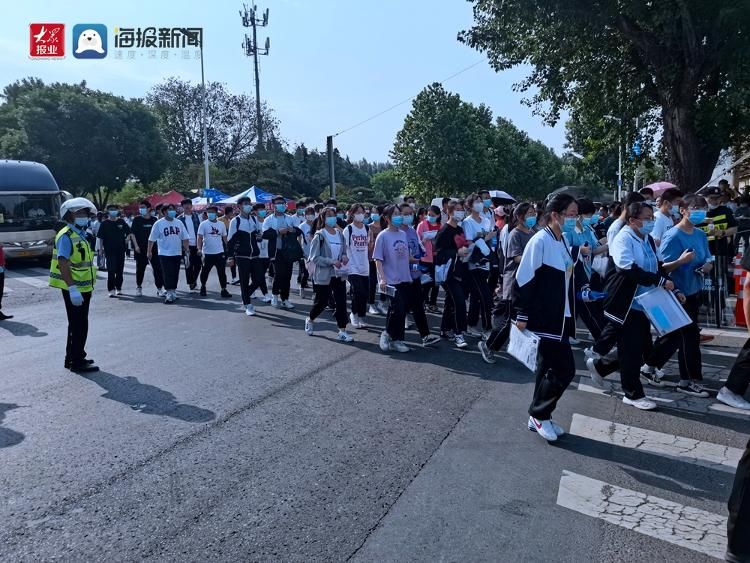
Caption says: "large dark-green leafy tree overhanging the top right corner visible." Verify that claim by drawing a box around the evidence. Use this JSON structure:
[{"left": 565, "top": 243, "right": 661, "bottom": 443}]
[{"left": 459, "top": 0, "right": 750, "bottom": 194}]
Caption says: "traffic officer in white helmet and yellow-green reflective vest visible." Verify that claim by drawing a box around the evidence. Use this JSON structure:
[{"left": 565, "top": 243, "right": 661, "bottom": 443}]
[{"left": 49, "top": 197, "right": 99, "bottom": 373}]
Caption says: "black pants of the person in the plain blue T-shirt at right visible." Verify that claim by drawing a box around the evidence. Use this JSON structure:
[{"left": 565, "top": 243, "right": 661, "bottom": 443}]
[{"left": 646, "top": 293, "right": 703, "bottom": 381}]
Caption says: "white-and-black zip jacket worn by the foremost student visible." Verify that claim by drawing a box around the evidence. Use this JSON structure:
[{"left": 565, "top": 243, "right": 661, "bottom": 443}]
[{"left": 512, "top": 228, "right": 575, "bottom": 341}]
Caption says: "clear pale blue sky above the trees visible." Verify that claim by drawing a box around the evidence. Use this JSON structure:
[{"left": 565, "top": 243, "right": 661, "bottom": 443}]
[{"left": 0, "top": 0, "right": 565, "bottom": 161}]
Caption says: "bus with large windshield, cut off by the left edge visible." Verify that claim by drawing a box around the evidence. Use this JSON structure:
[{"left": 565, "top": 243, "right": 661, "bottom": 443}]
[{"left": 0, "top": 160, "right": 66, "bottom": 258}]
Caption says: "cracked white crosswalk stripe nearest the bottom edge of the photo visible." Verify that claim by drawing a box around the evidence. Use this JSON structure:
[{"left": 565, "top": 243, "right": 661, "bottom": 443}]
[{"left": 557, "top": 471, "right": 727, "bottom": 558}]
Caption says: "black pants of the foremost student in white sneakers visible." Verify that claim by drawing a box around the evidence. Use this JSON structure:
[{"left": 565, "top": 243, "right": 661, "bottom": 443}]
[{"left": 529, "top": 338, "right": 576, "bottom": 420}]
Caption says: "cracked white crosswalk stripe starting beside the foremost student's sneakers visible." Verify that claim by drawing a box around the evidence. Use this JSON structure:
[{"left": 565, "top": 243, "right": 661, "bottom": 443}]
[{"left": 570, "top": 413, "right": 743, "bottom": 473}]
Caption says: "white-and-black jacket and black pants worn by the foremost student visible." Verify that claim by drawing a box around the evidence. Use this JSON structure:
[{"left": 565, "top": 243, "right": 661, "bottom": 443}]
[{"left": 513, "top": 228, "right": 576, "bottom": 420}]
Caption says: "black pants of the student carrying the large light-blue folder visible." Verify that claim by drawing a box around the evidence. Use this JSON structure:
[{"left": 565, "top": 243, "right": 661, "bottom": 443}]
[{"left": 595, "top": 309, "right": 653, "bottom": 401}]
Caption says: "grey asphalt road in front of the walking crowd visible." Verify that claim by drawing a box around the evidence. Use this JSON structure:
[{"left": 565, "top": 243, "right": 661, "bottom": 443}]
[{"left": 0, "top": 262, "right": 750, "bottom": 562}]
